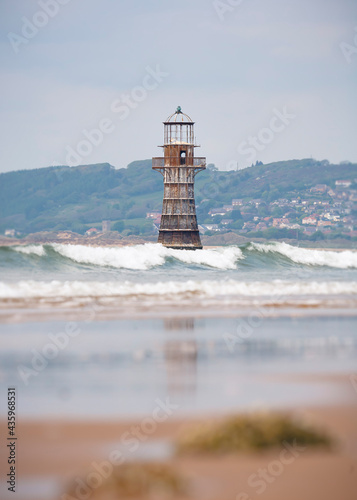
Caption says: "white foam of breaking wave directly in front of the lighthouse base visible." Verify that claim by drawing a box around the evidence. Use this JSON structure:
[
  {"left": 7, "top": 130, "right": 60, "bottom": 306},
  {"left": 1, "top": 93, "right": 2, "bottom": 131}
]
[{"left": 52, "top": 243, "right": 243, "bottom": 270}]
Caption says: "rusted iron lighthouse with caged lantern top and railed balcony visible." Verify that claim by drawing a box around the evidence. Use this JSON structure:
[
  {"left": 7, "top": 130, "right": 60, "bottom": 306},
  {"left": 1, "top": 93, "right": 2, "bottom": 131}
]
[{"left": 152, "top": 106, "right": 206, "bottom": 250}]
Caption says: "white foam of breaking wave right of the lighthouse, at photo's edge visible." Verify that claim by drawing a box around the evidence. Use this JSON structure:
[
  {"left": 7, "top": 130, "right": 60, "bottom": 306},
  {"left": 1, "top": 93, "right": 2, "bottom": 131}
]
[{"left": 250, "top": 243, "right": 357, "bottom": 269}]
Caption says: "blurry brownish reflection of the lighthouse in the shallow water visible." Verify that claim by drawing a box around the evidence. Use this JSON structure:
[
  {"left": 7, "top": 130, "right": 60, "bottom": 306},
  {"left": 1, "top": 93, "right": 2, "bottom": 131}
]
[{"left": 164, "top": 318, "right": 197, "bottom": 396}]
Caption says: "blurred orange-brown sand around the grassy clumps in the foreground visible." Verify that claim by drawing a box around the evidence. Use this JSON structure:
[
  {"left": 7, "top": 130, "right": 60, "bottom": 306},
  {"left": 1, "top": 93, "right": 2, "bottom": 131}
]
[{"left": 1, "top": 402, "right": 357, "bottom": 500}]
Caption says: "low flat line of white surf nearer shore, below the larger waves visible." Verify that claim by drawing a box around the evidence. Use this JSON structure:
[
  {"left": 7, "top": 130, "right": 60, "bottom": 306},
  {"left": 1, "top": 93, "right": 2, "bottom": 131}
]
[{"left": 0, "top": 280, "right": 357, "bottom": 300}]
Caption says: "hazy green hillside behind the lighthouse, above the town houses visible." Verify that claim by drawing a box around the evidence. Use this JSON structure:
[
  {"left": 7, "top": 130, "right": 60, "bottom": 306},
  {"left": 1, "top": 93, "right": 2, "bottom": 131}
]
[{"left": 0, "top": 159, "right": 357, "bottom": 234}]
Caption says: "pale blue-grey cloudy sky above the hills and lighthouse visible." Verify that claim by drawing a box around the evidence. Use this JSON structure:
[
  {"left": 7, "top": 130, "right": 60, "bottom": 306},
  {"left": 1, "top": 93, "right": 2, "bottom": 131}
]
[{"left": 0, "top": 0, "right": 357, "bottom": 172}]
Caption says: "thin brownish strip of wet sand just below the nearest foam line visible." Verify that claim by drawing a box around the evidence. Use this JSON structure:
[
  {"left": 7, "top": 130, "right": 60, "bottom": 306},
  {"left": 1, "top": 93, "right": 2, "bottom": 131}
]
[{"left": 0, "top": 296, "right": 357, "bottom": 324}]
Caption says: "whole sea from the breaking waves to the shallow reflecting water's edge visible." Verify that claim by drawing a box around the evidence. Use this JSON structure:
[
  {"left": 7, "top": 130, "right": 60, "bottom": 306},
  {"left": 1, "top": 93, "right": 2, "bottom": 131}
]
[{"left": 0, "top": 242, "right": 357, "bottom": 420}]
